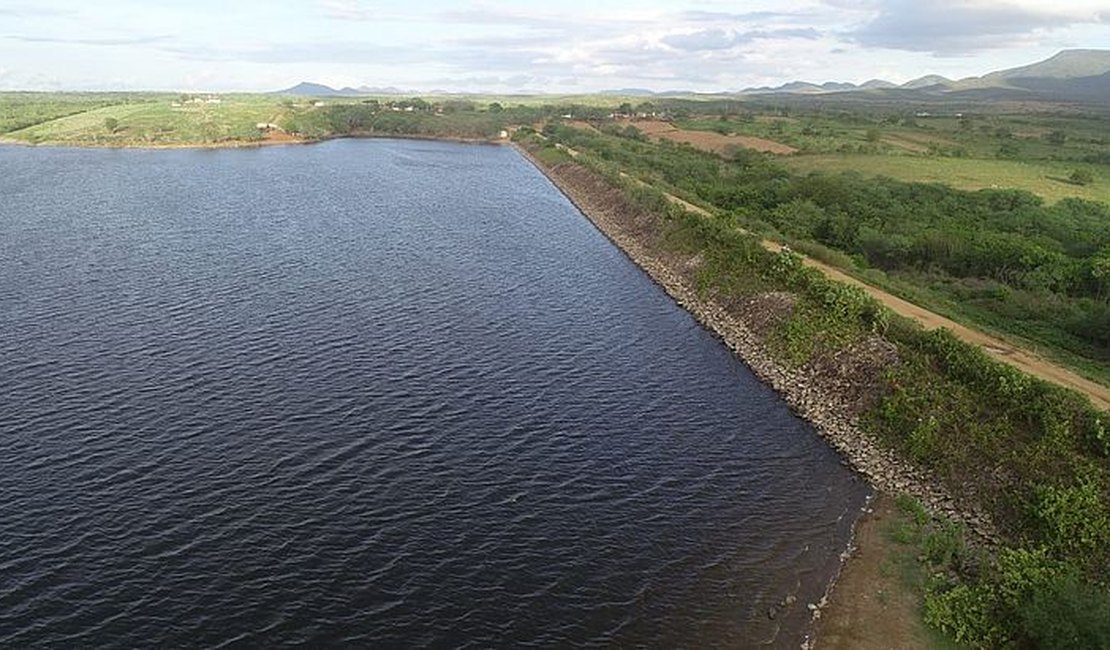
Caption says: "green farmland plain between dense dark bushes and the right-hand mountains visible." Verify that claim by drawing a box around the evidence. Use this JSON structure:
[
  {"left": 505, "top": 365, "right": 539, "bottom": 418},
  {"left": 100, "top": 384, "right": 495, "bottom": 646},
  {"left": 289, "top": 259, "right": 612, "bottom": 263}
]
[{"left": 679, "top": 106, "right": 1110, "bottom": 202}]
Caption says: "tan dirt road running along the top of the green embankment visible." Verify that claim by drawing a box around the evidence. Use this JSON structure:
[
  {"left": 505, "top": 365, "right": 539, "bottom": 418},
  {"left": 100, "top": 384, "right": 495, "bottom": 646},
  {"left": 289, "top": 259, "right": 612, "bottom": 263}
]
[{"left": 550, "top": 144, "right": 1110, "bottom": 410}]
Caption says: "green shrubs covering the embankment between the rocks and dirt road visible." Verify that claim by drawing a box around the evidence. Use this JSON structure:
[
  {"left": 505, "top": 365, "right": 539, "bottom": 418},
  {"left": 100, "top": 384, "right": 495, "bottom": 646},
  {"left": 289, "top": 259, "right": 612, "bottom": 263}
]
[{"left": 521, "top": 134, "right": 1110, "bottom": 648}]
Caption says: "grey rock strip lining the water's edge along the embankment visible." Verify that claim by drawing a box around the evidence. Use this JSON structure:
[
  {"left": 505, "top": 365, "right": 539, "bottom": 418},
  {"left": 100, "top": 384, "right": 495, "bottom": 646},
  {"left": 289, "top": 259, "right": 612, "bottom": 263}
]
[{"left": 512, "top": 143, "right": 998, "bottom": 648}]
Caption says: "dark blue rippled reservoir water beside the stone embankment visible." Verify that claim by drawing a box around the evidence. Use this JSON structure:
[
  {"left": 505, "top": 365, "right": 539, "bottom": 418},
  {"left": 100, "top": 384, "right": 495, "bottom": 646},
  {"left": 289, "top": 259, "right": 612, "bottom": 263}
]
[{"left": 0, "top": 141, "right": 866, "bottom": 648}]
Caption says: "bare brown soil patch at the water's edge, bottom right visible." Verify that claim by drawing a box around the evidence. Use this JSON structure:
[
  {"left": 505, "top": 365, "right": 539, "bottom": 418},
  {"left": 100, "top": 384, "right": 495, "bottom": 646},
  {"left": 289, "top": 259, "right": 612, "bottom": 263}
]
[{"left": 815, "top": 495, "right": 929, "bottom": 650}]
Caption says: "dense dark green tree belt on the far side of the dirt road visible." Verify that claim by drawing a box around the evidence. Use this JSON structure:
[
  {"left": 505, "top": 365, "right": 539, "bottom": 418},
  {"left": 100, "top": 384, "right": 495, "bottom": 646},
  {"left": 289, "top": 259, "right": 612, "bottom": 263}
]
[{"left": 547, "top": 125, "right": 1110, "bottom": 364}]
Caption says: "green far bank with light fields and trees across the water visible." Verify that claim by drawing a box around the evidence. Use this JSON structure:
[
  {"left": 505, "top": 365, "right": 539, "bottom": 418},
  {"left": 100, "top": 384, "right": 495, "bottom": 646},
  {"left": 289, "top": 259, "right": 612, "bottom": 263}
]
[{"left": 0, "top": 93, "right": 611, "bottom": 146}]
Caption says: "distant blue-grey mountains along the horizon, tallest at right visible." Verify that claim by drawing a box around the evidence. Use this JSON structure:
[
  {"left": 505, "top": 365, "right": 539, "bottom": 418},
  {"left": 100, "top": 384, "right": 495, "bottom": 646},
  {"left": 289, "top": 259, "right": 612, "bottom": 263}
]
[{"left": 273, "top": 50, "right": 1110, "bottom": 104}]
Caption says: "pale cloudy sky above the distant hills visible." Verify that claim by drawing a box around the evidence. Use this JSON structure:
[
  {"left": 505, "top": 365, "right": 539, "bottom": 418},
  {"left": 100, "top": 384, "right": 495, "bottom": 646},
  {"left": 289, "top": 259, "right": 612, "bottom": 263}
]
[{"left": 0, "top": 0, "right": 1110, "bottom": 93}]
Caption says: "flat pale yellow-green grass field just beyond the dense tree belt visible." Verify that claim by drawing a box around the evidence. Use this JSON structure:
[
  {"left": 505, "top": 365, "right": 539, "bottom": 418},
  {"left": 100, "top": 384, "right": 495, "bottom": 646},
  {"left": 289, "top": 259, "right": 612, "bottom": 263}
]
[{"left": 783, "top": 154, "right": 1110, "bottom": 203}]
